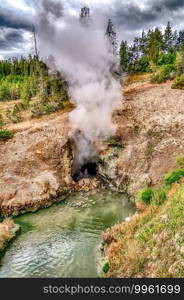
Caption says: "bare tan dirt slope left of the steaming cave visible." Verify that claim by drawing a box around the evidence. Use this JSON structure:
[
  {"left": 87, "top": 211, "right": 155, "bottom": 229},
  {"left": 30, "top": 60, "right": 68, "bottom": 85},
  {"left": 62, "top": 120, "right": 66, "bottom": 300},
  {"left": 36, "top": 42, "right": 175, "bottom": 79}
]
[{"left": 0, "top": 114, "right": 72, "bottom": 216}]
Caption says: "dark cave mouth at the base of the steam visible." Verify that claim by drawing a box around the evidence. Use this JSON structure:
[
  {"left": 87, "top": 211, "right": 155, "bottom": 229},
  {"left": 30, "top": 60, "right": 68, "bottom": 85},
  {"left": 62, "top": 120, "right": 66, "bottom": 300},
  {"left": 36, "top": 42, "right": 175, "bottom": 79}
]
[{"left": 72, "top": 162, "right": 98, "bottom": 182}]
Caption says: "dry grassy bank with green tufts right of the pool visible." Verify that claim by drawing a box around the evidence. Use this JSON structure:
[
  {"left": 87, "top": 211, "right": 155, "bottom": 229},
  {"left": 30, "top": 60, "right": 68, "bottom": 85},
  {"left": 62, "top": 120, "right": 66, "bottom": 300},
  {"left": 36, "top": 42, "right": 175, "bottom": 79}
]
[{"left": 103, "top": 182, "right": 184, "bottom": 278}]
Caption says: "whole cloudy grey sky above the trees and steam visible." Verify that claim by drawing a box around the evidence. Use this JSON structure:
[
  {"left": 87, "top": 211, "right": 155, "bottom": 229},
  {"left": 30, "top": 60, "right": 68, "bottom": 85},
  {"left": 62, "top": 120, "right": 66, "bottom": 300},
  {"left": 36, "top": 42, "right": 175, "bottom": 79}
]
[{"left": 0, "top": 0, "right": 184, "bottom": 59}]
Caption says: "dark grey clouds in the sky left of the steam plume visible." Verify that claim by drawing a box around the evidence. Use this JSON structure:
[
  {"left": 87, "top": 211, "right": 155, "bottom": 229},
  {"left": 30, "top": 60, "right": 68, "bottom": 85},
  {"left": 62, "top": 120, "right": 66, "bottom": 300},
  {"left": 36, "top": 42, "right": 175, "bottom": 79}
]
[{"left": 0, "top": 0, "right": 63, "bottom": 56}]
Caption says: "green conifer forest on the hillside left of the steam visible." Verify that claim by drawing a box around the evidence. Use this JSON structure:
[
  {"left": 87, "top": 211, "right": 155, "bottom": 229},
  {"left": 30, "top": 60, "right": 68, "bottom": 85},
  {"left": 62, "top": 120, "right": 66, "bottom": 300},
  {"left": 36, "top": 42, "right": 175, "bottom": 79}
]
[{"left": 0, "top": 56, "right": 71, "bottom": 140}]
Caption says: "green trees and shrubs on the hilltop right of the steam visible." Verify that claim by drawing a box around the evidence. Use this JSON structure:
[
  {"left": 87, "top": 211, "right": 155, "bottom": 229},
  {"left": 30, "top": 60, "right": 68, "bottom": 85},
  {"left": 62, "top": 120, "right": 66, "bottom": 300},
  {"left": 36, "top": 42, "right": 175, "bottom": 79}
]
[{"left": 119, "top": 22, "right": 184, "bottom": 89}]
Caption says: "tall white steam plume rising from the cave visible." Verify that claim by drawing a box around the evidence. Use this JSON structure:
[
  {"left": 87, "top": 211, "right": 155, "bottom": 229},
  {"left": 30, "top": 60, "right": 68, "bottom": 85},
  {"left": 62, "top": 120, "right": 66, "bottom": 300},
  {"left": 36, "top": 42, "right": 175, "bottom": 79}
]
[{"left": 36, "top": 0, "right": 122, "bottom": 177}]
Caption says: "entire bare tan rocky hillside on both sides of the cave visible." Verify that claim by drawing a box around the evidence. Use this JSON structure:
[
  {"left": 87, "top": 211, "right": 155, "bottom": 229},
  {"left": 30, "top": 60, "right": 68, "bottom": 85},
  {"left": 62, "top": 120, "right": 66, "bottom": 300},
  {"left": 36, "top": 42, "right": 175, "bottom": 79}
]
[{"left": 0, "top": 76, "right": 184, "bottom": 216}]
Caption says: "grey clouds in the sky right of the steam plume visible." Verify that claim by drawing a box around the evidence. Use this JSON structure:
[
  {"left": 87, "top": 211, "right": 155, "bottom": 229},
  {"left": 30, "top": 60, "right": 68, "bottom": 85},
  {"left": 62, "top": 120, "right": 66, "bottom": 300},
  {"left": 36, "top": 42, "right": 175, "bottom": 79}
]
[{"left": 85, "top": 0, "right": 184, "bottom": 42}]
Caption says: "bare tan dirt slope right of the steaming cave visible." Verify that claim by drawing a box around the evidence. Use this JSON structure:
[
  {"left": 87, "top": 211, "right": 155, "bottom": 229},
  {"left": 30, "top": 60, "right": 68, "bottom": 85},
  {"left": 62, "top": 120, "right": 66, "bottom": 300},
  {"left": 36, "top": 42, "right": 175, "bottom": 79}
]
[{"left": 100, "top": 82, "right": 184, "bottom": 193}]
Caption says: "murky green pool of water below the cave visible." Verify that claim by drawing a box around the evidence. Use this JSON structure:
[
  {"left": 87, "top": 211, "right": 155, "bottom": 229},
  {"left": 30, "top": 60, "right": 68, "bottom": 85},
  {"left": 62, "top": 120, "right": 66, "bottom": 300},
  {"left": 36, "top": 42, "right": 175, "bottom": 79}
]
[{"left": 0, "top": 191, "right": 134, "bottom": 277}]
